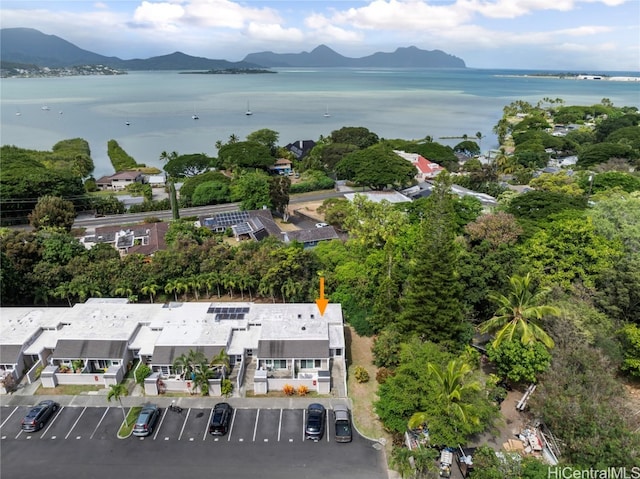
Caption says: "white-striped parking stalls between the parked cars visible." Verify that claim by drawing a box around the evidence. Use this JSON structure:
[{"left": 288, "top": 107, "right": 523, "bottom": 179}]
[{"left": 0, "top": 406, "right": 352, "bottom": 447}]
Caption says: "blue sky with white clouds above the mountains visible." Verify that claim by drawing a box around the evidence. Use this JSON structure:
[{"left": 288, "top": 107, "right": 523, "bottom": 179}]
[{"left": 0, "top": 0, "right": 640, "bottom": 73}]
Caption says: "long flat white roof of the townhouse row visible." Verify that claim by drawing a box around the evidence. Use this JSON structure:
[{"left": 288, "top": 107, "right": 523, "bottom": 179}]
[{"left": 0, "top": 298, "right": 344, "bottom": 354}]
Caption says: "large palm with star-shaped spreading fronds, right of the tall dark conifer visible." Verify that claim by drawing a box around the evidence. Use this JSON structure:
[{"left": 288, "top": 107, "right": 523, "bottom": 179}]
[{"left": 480, "top": 273, "right": 561, "bottom": 348}]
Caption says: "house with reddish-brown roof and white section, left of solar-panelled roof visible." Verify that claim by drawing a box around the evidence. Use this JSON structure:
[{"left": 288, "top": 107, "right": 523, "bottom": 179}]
[{"left": 80, "top": 222, "right": 169, "bottom": 256}]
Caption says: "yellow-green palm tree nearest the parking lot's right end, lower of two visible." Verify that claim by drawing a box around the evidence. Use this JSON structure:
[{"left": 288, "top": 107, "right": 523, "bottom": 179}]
[{"left": 408, "top": 359, "right": 481, "bottom": 429}]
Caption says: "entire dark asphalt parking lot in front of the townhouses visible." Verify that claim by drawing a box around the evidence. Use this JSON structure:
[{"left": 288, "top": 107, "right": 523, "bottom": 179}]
[{"left": 0, "top": 404, "right": 388, "bottom": 479}]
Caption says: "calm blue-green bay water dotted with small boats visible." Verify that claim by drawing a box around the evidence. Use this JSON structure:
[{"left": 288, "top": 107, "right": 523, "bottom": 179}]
[{"left": 0, "top": 68, "right": 640, "bottom": 177}]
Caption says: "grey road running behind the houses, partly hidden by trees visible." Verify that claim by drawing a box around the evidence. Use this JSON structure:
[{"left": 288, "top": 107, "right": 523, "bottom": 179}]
[{"left": 73, "top": 190, "right": 343, "bottom": 228}]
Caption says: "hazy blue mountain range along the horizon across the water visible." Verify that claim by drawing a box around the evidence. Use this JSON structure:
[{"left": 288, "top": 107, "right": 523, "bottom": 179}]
[{"left": 0, "top": 28, "right": 465, "bottom": 70}]
